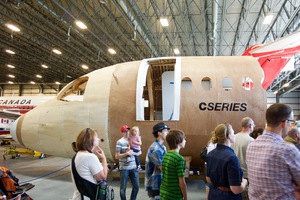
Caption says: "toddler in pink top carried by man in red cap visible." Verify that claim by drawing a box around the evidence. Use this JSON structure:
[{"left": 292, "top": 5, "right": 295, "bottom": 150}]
[{"left": 129, "top": 126, "right": 142, "bottom": 170}]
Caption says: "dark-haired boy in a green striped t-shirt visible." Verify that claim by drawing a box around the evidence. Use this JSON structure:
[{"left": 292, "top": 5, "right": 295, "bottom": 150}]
[{"left": 160, "top": 129, "right": 187, "bottom": 200}]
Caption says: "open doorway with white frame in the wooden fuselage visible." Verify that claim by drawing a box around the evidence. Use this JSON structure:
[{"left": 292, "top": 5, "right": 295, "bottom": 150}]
[{"left": 137, "top": 58, "right": 181, "bottom": 121}]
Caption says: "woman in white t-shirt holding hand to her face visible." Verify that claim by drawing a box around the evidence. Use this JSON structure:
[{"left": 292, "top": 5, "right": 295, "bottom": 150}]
[{"left": 72, "top": 128, "right": 108, "bottom": 200}]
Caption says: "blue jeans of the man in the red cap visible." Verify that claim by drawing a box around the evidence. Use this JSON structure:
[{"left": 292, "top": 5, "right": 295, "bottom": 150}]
[{"left": 120, "top": 169, "right": 140, "bottom": 200}]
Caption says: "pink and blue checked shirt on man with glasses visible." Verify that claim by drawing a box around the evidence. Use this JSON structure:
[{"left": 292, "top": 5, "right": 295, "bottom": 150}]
[{"left": 246, "top": 132, "right": 300, "bottom": 200}]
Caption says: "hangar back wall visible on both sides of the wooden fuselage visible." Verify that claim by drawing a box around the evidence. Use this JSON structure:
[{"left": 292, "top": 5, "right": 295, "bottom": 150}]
[{"left": 0, "top": 83, "right": 300, "bottom": 119}]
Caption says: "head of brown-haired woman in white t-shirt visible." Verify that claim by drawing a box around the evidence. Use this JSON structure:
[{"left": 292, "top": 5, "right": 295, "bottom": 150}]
[{"left": 76, "top": 128, "right": 100, "bottom": 152}]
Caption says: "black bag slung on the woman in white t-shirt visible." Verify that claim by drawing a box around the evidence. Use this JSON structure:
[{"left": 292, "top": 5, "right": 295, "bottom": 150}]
[{"left": 72, "top": 154, "right": 115, "bottom": 200}]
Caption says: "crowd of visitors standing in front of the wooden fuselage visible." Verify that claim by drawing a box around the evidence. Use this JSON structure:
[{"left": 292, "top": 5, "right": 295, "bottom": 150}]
[{"left": 73, "top": 103, "right": 300, "bottom": 200}]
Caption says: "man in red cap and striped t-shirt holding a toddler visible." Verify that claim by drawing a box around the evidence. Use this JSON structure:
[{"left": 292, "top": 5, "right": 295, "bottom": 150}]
[{"left": 115, "top": 125, "right": 140, "bottom": 200}]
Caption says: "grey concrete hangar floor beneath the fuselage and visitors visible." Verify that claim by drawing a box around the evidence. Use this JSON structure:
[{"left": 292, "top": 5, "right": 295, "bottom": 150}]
[{"left": 0, "top": 143, "right": 206, "bottom": 200}]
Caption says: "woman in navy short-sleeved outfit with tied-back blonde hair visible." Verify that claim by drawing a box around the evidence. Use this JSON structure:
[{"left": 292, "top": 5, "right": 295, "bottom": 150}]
[{"left": 206, "top": 123, "right": 248, "bottom": 200}]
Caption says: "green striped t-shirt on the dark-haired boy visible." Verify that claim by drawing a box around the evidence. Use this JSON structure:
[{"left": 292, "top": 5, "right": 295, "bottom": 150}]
[{"left": 160, "top": 151, "right": 185, "bottom": 200}]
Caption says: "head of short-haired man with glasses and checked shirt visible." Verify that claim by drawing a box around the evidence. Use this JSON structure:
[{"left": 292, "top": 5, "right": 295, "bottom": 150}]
[{"left": 266, "top": 103, "right": 295, "bottom": 135}]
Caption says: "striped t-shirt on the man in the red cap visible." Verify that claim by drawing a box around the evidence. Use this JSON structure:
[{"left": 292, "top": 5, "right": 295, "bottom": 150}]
[{"left": 116, "top": 137, "right": 136, "bottom": 170}]
